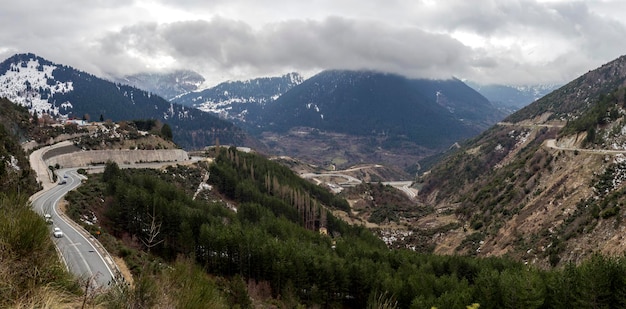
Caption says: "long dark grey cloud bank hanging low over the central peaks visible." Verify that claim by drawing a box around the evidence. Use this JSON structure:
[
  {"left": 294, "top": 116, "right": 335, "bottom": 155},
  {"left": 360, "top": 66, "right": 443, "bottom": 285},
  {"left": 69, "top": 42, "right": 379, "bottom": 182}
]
[{"left": 94, "top": 17, "right": 472, "bottom": 77}]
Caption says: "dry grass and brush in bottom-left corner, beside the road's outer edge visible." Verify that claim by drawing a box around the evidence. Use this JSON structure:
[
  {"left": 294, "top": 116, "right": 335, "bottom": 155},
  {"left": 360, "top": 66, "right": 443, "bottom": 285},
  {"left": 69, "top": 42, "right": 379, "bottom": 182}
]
[{"left": 0, "top": 195, "right": 80, "bottom": 308}]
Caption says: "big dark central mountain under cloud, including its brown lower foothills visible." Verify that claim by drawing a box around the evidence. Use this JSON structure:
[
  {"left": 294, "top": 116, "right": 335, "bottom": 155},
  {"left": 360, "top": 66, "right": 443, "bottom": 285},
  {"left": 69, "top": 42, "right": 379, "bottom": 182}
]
[{"left": 242, "top": 70, "right": 505, "bottom": 168}]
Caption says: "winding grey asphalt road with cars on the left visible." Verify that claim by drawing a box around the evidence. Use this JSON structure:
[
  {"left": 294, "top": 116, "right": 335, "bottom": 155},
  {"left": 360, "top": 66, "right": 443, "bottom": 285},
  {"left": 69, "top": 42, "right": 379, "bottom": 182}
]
[{"left": 33, "top": 169, "right": 114, "bottom": 288}]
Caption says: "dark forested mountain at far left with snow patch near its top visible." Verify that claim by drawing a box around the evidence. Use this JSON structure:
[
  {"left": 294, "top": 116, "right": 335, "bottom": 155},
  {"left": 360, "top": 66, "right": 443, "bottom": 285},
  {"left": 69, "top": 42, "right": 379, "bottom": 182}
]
[{"left": 0, "top": 54, "right": 250, "bottom": 149}]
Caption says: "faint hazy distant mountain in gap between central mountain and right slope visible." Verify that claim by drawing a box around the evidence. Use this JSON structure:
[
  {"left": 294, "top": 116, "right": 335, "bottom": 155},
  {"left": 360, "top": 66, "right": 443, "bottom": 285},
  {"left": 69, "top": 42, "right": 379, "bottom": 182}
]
[{"left": 466, "top": 82, "right": 560, "bottom": 112}]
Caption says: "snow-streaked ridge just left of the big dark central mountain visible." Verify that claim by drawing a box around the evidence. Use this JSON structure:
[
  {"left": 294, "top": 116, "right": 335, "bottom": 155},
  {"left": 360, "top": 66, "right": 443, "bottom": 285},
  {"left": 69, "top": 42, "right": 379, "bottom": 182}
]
[{"left": 172, "top": 73, "right": 304, "bottom": 122}]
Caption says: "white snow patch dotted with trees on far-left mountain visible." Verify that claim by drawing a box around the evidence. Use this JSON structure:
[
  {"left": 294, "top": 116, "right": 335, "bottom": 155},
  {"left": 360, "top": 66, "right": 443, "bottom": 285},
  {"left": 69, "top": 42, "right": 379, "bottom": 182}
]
[{"left": 0, "top": 58, "right": 74, "bottom": 115}]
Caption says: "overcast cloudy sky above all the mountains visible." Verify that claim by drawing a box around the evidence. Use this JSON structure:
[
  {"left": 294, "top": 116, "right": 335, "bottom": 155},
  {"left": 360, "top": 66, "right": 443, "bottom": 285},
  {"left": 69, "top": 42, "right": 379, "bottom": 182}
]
[{"left": 0, "top": 0, "right": 626, "bottom": 84}]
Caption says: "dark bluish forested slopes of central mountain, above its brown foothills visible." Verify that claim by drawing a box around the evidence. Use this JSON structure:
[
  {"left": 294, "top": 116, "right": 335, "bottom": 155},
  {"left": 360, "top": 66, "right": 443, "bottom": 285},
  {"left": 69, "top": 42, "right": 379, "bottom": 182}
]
[{"left": 249, "top": 70, "right": 504, "bottom": 148}]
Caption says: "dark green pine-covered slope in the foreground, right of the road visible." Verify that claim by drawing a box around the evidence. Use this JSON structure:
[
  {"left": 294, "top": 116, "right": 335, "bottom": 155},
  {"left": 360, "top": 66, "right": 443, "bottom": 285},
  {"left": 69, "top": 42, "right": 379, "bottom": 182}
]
[{"left": 62, "top": 148, "right": 626, "bottom": 308}]
